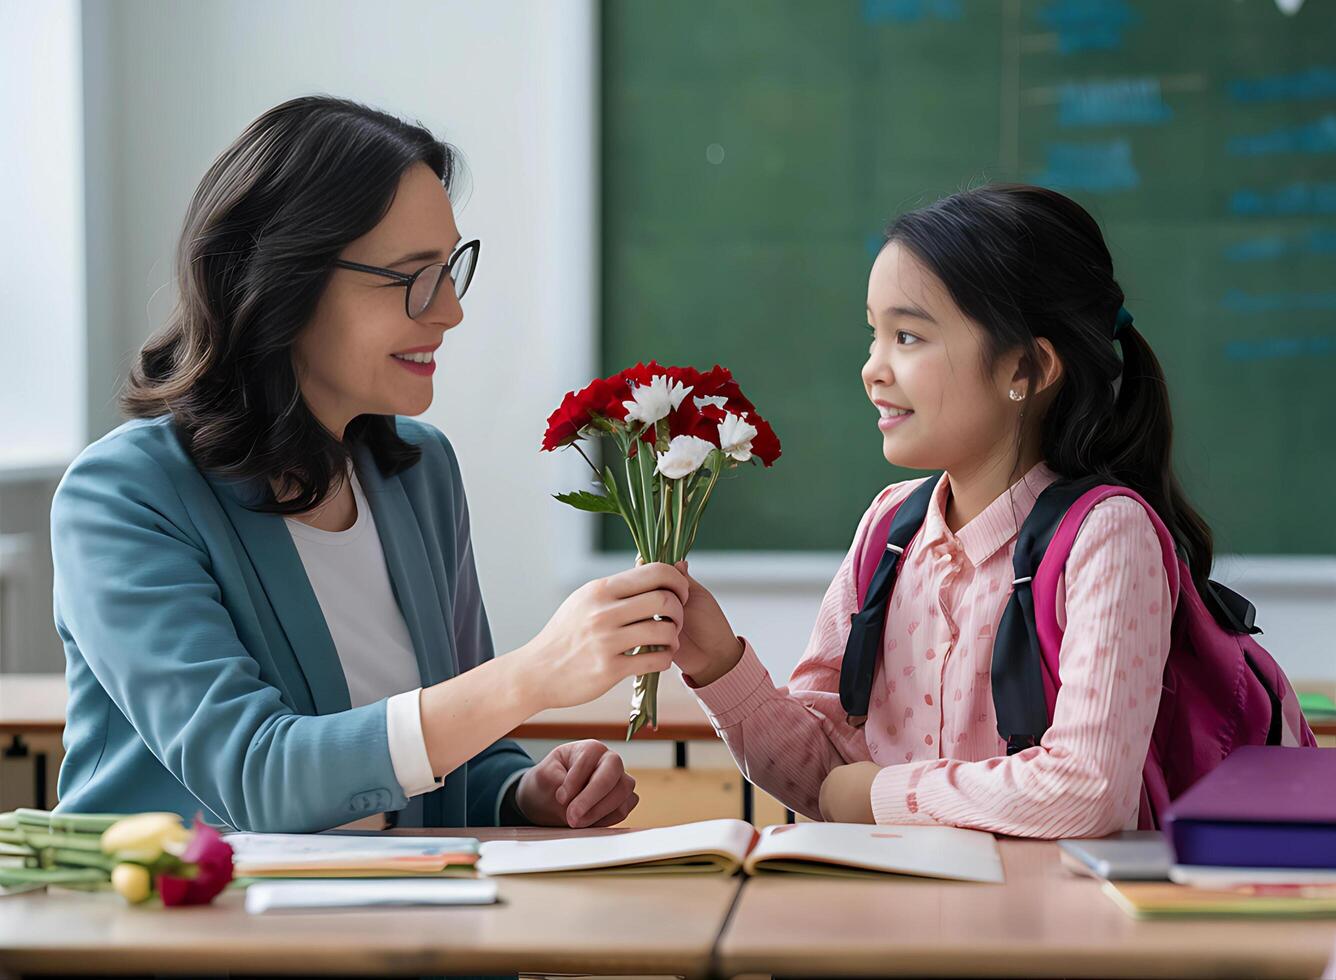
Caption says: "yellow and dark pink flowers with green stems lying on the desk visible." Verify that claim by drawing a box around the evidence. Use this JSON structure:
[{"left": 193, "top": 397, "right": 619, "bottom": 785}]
[{"left": 0, "top": 809, "right": 232, "bottom": 905}]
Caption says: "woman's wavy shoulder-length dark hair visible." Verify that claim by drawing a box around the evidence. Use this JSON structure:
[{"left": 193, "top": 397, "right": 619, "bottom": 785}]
[{"left": 120, "top": 96, "right": 458, "bottom": 514}]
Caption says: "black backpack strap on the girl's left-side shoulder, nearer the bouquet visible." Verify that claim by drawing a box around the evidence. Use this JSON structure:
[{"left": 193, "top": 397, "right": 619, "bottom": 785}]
[{"left": 839, "top": 479, "right": 938, "bottom": 725}]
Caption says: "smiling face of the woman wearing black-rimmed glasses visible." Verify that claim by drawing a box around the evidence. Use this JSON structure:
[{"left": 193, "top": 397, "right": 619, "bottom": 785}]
[{"left": 293, "top": 163, "right": 464, "bottom": 438}]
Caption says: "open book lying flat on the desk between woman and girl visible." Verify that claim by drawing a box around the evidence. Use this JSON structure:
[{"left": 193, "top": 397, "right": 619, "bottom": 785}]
[{"left": 477, "top": 820, "right": 1003, "bottom": 883}]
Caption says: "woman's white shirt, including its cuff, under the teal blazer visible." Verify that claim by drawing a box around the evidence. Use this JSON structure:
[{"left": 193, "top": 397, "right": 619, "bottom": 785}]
[{"left": 286, "top": 467, "right": 441, "bottom": 797}]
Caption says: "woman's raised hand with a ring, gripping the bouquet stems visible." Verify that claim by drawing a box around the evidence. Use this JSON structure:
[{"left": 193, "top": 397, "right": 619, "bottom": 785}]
[{"left": 518, "top": 562, "right": 688, "bottom": 708}]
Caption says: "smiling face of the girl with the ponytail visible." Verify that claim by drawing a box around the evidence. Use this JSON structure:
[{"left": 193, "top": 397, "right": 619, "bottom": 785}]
[{"left": 863, "top": 242, "right": 1029, "bottom": 473}]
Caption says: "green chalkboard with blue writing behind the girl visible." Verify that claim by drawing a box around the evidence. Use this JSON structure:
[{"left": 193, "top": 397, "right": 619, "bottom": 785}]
[{"left": 601, "top": 0, "right": 1336, "bottom": 554}]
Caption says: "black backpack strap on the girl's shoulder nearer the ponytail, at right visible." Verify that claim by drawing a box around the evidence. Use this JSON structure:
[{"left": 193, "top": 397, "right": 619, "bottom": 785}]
[{"left": 993, "top": 477, "right": 1109, "bottom": 756}]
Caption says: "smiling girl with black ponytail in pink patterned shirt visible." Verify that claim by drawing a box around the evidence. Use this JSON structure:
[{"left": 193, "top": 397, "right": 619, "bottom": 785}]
[{"left": 676, "top": 186, "right": 1212, "bottom": 837}]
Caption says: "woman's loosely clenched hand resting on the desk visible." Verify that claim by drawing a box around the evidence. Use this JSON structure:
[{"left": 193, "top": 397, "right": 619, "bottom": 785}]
[{"left": 514, "top": 738, "right": 640, "bottom": 826}]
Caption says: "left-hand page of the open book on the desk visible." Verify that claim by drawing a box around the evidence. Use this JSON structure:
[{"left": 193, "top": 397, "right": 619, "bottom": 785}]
[{"left": 477, "top": 820, "right": 756, "bottom": 875}]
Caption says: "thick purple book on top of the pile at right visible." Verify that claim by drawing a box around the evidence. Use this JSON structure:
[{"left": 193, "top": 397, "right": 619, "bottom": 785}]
[{"left": 1165, "top": 745, "right": 1336, "bottom": 868}]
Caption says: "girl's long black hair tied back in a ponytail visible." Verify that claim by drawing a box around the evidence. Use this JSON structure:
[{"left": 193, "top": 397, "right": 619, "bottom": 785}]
[{"left": 886, "top": 184, "right": 1213, "bottom": 594}]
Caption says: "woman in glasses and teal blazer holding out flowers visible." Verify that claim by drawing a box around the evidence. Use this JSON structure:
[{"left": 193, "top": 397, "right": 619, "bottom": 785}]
[{"left": 52, "top": 97, "right": 687, "bottom": 832}]
